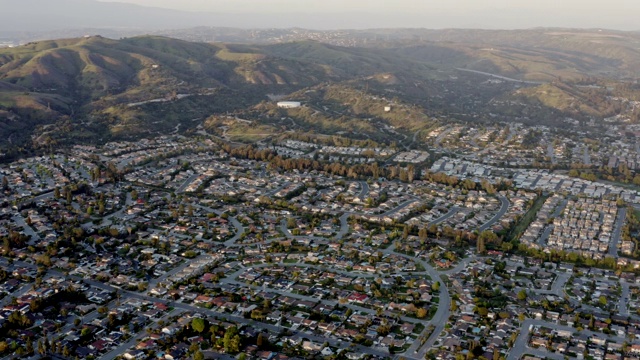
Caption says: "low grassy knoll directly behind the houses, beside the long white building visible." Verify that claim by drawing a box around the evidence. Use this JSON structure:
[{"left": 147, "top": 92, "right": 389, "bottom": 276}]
[{"left": 204, "top": 82, "right": 438, "bottom": 145}]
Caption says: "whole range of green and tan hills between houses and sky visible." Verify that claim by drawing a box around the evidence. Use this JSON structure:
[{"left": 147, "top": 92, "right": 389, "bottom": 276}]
[{"left": 0, "top": 30, "right": 640, "bottom": 159}]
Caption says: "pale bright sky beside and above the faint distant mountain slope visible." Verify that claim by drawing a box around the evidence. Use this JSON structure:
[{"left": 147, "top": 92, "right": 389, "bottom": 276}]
[{"left": 91, "top": 0, "right": 640, "bottom": 30}]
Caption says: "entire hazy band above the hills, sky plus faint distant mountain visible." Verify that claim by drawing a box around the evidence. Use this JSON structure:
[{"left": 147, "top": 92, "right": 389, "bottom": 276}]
[{"left": 0, "top": 0, "right": 640, "bottom": 32}]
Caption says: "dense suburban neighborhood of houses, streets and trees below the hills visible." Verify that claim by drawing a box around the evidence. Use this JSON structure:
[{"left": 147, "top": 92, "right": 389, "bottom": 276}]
[{"left": 0, "top": 136, "right": 640, "bottom": 360}]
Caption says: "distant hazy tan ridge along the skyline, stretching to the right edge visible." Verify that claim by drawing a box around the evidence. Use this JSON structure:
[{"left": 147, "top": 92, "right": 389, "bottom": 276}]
[{"left": 172, "top": 28, "right": 640, "bottom": 81}]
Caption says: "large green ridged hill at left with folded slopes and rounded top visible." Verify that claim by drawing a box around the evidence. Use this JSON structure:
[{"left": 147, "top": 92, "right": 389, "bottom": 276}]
[{"left": 0, "top": 36, "right": 352, "bottom": 150}]
